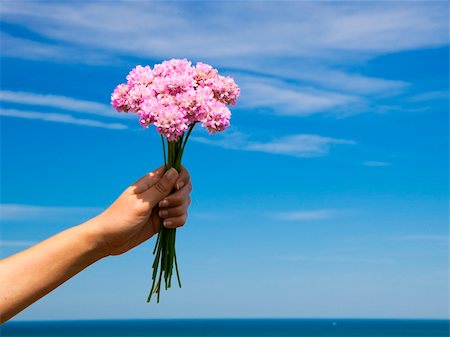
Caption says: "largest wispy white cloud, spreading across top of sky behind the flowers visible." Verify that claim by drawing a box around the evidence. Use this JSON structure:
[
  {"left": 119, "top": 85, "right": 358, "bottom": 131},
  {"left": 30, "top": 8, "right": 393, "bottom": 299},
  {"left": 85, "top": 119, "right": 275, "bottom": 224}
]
[{"left": 0, "top": 1, "right": 442, "bottom": 116}]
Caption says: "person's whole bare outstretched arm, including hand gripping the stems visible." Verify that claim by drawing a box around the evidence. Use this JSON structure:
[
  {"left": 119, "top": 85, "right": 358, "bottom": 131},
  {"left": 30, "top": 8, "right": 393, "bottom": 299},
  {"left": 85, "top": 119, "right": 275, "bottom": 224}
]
[{"left": 0, "top": 167, "right": 192, "bottom": 323}]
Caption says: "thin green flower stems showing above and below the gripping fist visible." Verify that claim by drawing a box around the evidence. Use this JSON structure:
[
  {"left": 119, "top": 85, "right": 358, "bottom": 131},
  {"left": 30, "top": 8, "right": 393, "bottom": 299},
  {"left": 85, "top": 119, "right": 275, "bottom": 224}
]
[{"left": 147, "top": 123, "right": 195, "bottom": 303}]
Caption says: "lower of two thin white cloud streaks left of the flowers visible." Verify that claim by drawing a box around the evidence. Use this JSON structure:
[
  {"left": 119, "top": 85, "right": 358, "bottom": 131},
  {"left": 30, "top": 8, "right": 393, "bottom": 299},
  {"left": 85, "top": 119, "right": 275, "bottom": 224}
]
[{"left": 0, "top": 109, "right": 128, "bottom": 130}]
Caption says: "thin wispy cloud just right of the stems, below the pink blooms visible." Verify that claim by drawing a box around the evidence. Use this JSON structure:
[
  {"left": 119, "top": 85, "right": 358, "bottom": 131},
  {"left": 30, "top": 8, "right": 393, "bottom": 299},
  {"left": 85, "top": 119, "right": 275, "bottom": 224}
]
[{"left": 192, "top": 132, "right": 355, "bottom": 158}]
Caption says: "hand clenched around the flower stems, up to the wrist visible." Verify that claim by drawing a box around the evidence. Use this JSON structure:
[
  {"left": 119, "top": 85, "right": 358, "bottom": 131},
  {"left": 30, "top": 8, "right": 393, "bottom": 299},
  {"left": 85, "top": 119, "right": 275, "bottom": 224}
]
[{"left": 96, "top": 167, "right": 192, "bottom": 255}]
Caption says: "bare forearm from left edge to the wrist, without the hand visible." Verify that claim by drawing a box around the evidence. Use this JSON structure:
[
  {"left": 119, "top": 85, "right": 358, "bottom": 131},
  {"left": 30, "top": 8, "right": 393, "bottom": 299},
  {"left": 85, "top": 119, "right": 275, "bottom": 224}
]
[{"left": 0, "top": 218, "right": 105, "bottom": 323}]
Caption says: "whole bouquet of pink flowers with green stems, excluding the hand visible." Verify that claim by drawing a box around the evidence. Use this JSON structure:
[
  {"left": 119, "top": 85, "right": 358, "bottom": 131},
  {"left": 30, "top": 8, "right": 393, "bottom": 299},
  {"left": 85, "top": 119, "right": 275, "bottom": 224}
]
[{"left": 111, "top": 59, "right": 240, "bottom": 303}]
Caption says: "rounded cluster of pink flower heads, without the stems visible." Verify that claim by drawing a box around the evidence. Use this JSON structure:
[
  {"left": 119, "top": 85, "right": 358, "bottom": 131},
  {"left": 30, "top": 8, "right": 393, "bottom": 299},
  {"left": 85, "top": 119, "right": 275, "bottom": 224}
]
[{"left": 111, "top": 59, "right": 240, "bottom": 141}]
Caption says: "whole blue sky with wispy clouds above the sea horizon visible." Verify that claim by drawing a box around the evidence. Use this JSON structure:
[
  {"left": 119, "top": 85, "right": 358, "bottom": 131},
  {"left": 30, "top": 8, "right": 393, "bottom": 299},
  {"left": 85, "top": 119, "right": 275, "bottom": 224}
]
[{"left": 0, "top": 1, "right": 449, "bottom": 320}]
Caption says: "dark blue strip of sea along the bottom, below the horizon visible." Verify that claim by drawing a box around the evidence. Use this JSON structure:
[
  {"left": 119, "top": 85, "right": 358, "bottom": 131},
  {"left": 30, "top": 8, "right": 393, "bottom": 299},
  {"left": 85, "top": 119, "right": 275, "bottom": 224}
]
[{"left": 0, "top": 319, "right": 449, "bottom": 337}]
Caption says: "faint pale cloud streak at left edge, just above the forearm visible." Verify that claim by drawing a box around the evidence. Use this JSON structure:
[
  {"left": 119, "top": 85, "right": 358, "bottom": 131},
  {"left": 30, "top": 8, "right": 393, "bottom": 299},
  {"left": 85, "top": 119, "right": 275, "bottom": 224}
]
[{"left": 0, "top": 204, "right": 102, "bottom": 222}]
